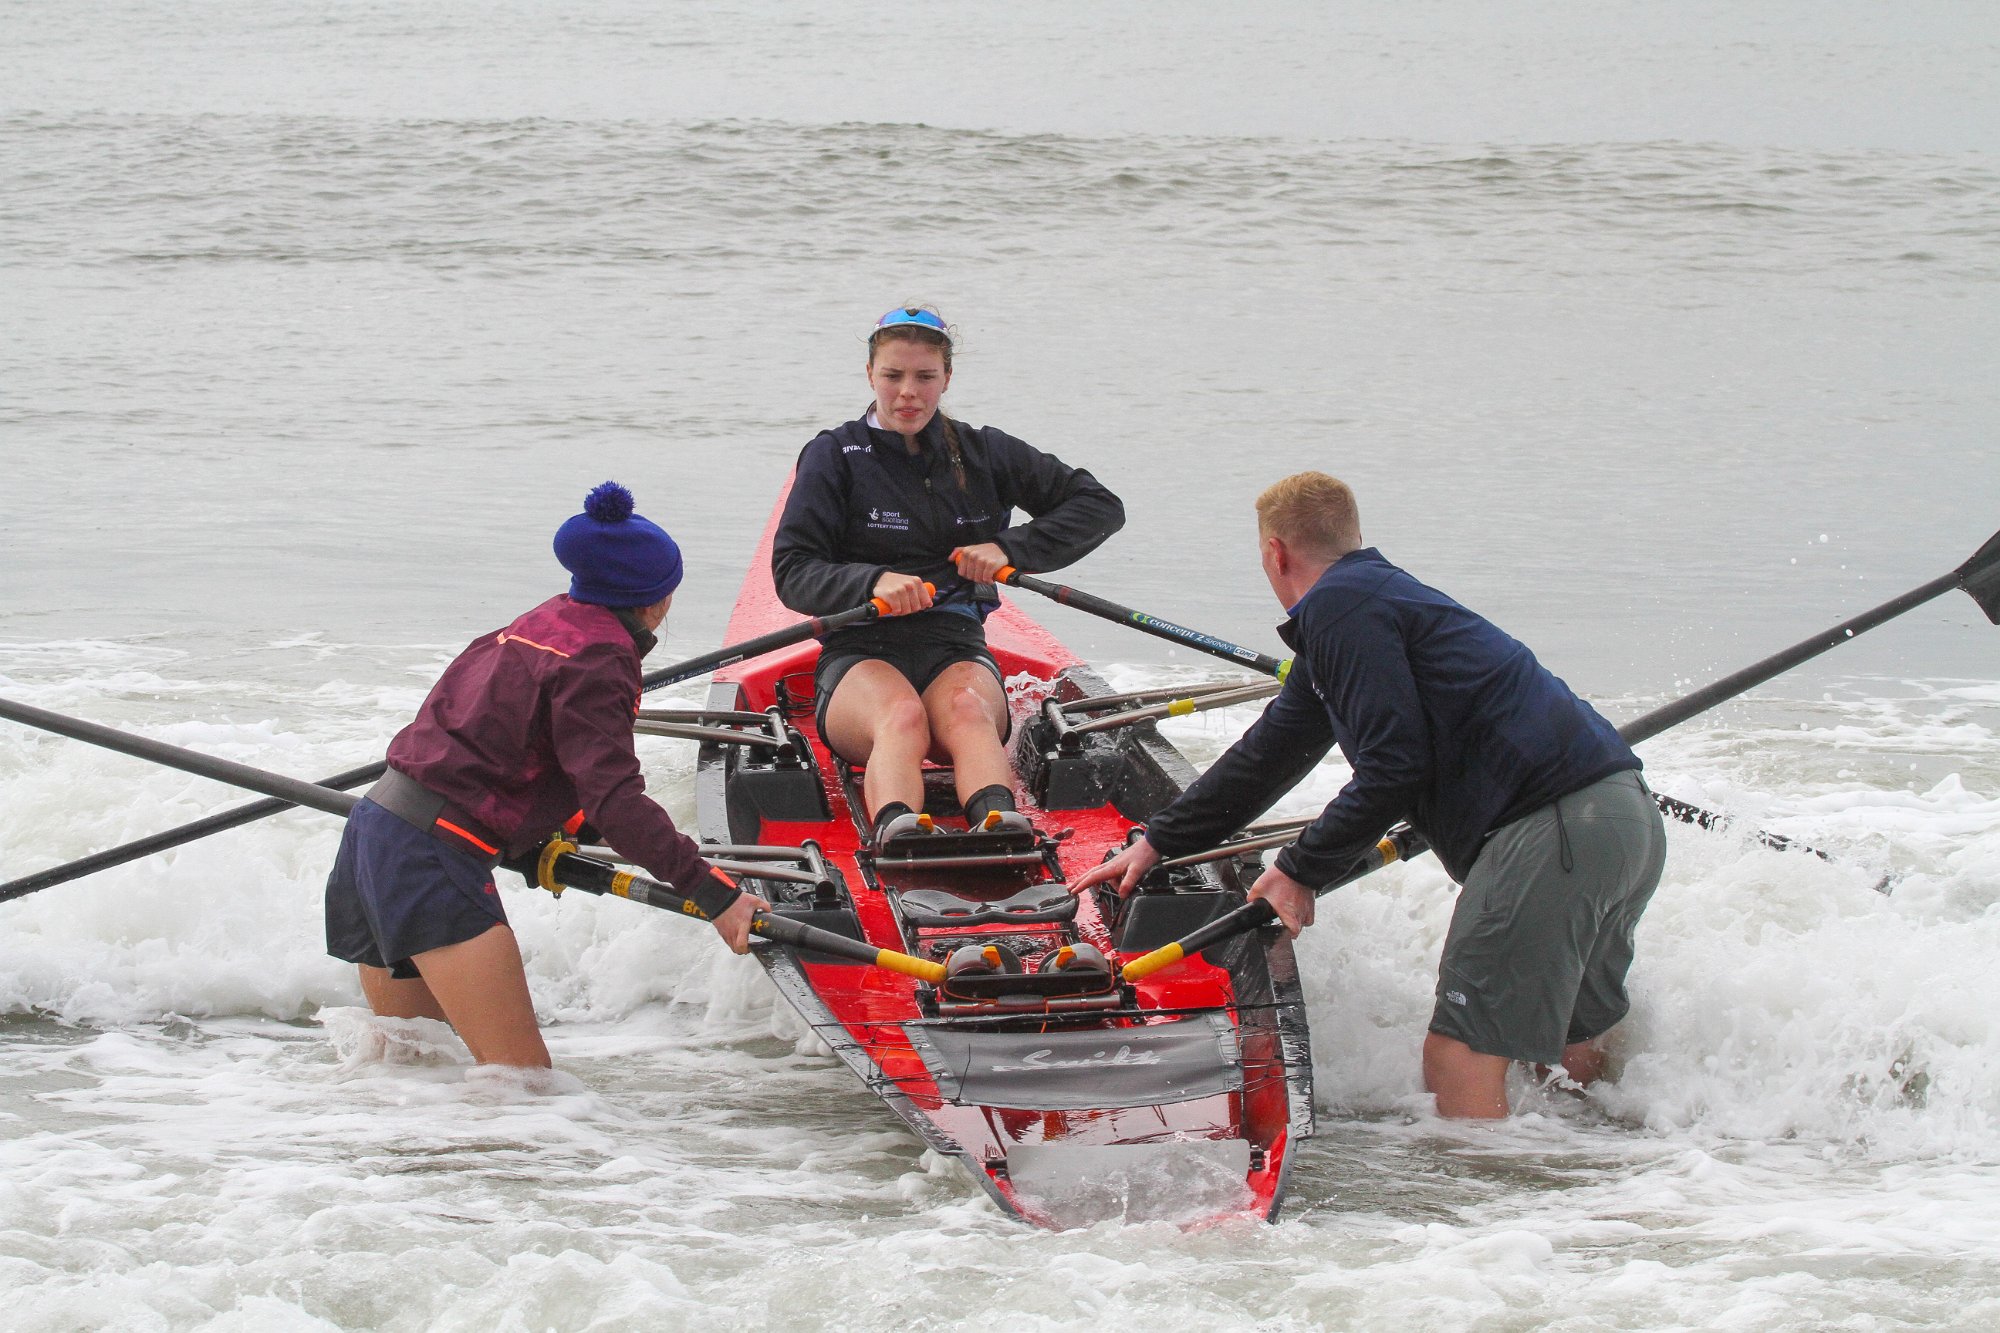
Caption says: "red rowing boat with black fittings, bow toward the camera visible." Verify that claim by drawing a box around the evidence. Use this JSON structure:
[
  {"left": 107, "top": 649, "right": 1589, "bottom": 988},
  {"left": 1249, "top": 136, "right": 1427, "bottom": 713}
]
[{"left": 680, "top": 496, "right": 1312, "bottom": 1227}]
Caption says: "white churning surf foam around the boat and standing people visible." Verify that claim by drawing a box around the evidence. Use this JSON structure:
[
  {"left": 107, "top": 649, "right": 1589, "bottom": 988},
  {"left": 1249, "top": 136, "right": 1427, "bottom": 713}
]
[{"left": 0, "top": 652, "right": 2000, "bottom": 1329}]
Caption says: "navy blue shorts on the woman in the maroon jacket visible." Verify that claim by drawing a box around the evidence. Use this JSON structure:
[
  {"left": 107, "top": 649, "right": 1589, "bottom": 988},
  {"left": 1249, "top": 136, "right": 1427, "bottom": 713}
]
[{"left": 326, "top": 797, "right": 506, "bottom": 981}]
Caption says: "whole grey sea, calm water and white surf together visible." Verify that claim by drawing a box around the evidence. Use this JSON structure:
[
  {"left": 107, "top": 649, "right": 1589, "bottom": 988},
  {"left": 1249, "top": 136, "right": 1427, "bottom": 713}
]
[{"left": 0, "top": 0, "right": 2000, "bottom": 1329}]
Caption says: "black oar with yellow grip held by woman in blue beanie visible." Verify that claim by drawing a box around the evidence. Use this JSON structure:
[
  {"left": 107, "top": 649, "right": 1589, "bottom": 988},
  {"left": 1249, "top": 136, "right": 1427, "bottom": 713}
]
[{"left": 0, "top": 699, "right": 944, "bottom": 981}]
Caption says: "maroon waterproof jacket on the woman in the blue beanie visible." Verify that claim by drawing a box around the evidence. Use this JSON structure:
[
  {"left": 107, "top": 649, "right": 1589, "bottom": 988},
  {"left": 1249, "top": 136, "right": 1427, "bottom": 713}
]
[{"left": 388, "top": 596, "right": 708, "bottom": 891}]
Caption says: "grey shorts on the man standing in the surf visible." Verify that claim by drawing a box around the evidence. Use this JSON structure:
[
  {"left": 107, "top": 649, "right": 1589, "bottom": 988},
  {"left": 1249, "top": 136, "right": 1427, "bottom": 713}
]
[{"left": 1430, "top": 769, "right": 1666, "bottom": 1065}]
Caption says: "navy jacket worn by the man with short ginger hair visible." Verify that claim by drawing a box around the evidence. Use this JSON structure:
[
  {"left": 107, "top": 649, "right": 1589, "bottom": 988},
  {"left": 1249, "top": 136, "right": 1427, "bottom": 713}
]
[{"left": 1146, "top": 546, "right": 1640, "bottom": 889}]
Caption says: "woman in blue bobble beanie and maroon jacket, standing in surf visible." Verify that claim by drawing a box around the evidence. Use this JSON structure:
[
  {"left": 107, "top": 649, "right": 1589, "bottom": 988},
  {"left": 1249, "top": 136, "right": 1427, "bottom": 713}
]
[{"left": 326, "top": 482, "right": 768, "bottom": 1069}]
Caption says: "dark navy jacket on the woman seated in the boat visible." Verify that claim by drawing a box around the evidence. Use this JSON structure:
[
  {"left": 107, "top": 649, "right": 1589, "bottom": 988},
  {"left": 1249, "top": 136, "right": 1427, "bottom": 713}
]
[{"left": 770, "top": 412, "right": 1124, "bottom": 616}]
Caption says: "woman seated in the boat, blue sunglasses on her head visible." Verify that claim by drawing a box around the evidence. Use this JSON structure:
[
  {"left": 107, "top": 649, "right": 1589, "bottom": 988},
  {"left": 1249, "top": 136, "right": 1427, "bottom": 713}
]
[{"left": 770, "top": 306, "right": 1124, "bottom": 847}]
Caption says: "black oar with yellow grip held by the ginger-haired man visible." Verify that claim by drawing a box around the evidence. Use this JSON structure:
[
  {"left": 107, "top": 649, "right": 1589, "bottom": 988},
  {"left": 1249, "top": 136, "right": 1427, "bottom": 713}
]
[{"left": 1122, "top": 532, "right": 2000, "bottom": 981}]
